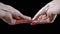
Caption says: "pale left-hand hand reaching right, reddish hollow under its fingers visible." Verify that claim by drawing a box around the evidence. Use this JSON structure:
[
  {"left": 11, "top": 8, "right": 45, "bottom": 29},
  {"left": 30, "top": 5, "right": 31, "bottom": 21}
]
[{"left": 0, "top": 3, "right": 31, "bottom": 25}]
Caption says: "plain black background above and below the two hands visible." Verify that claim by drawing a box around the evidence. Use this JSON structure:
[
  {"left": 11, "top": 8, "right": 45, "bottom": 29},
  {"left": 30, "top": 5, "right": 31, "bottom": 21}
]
[{"left": 0, "top": 0, "right": 60, "bottom": 33}]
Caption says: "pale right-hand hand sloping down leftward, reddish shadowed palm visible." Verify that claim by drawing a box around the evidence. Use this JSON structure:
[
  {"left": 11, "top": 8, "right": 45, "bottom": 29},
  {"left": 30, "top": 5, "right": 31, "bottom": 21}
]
[{"left": 31, "top": 0, "right": 60, "bottom": 25}]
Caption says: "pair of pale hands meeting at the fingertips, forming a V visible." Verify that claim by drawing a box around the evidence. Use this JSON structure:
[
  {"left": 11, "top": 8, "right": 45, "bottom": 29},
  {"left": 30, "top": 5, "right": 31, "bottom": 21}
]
[{"left": 0, "top": 1, "right": 60, "bottom": 25}]
